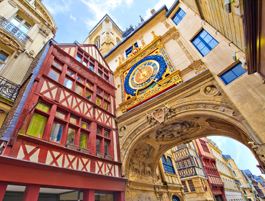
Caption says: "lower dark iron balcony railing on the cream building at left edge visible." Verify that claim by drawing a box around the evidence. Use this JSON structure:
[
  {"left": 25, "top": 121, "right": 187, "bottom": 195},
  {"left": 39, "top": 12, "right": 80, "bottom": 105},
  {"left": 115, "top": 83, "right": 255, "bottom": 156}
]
[{"left": 0, "top": 76, "right": 20, "bottom": 101}]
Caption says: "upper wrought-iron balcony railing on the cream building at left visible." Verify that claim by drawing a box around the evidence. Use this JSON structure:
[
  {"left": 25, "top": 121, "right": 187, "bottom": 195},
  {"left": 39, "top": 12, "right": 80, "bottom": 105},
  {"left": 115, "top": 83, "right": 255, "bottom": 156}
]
[{"left": 0, "top": 17, "right": 30, "bottom": 44}]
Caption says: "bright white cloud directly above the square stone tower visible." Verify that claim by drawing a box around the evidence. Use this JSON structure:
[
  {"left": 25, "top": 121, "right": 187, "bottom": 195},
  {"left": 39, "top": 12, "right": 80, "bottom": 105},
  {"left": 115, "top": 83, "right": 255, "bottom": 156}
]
[{"left": 81, "top": 0, "right": 130, "bottom": 30}]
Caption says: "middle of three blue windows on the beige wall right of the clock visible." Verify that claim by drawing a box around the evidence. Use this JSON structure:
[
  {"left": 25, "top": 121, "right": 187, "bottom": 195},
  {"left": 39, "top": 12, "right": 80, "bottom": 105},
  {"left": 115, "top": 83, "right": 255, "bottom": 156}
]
[{"left": 191, "top": 29, "right": 218, "bottom": 56}]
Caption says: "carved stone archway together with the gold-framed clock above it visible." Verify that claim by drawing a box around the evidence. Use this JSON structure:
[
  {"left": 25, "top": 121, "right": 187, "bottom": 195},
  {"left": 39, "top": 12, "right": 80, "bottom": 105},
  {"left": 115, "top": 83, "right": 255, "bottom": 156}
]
[{"left": 112, "top": 30, "right": 265, "bottom": 201}]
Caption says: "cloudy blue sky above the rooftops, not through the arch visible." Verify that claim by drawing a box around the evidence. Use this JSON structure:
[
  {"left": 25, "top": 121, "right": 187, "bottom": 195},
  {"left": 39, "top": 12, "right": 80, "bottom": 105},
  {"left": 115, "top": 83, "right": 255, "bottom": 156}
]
[{"left": 42, "top": 0, "right": 175, "bottom": 43}]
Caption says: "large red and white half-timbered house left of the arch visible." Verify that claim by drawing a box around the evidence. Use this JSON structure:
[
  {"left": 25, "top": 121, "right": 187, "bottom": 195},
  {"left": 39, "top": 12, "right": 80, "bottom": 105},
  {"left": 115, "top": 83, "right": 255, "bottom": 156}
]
[{"left": 0, "top": 42, "right": 126, "bottom": 201}]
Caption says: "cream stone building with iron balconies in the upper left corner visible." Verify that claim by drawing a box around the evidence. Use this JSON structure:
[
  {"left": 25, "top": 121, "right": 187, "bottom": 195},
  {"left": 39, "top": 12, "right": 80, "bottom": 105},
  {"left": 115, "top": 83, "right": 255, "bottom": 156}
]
[{"left": 0, "top": 0, "right": 57, "bottom": 127}]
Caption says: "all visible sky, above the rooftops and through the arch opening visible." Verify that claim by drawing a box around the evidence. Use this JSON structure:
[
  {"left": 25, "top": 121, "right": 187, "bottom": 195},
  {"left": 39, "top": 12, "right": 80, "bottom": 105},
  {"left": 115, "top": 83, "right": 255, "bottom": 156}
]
[{"left": 42, "top": 0, "right": 261, "bottom": 175}]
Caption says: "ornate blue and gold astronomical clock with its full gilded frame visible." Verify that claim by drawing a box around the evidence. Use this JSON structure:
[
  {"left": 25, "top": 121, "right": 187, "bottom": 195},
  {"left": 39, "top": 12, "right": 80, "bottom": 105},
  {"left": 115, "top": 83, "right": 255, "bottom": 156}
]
[{"left": 117, "top": 32, "right": 182, "bottom": 112}]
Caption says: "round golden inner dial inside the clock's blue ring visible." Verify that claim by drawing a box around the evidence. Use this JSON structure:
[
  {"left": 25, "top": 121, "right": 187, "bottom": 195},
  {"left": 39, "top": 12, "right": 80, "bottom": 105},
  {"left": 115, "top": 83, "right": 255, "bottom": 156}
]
[{"left": 129, "top": 60, "right": 159, "bottom": 89}]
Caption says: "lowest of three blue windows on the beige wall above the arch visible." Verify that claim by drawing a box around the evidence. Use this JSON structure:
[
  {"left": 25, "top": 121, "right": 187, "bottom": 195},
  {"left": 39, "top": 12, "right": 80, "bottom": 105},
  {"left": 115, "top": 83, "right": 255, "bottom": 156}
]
[{"left": 220, "top": 62, "right": 247, "bottom": 85}]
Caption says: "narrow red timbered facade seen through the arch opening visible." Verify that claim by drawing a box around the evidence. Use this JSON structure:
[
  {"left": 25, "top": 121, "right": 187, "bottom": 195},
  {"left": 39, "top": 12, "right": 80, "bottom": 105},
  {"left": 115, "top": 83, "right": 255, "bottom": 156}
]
[{"left": 195, "top": 137, "right": 226, "bottom": 201}]
